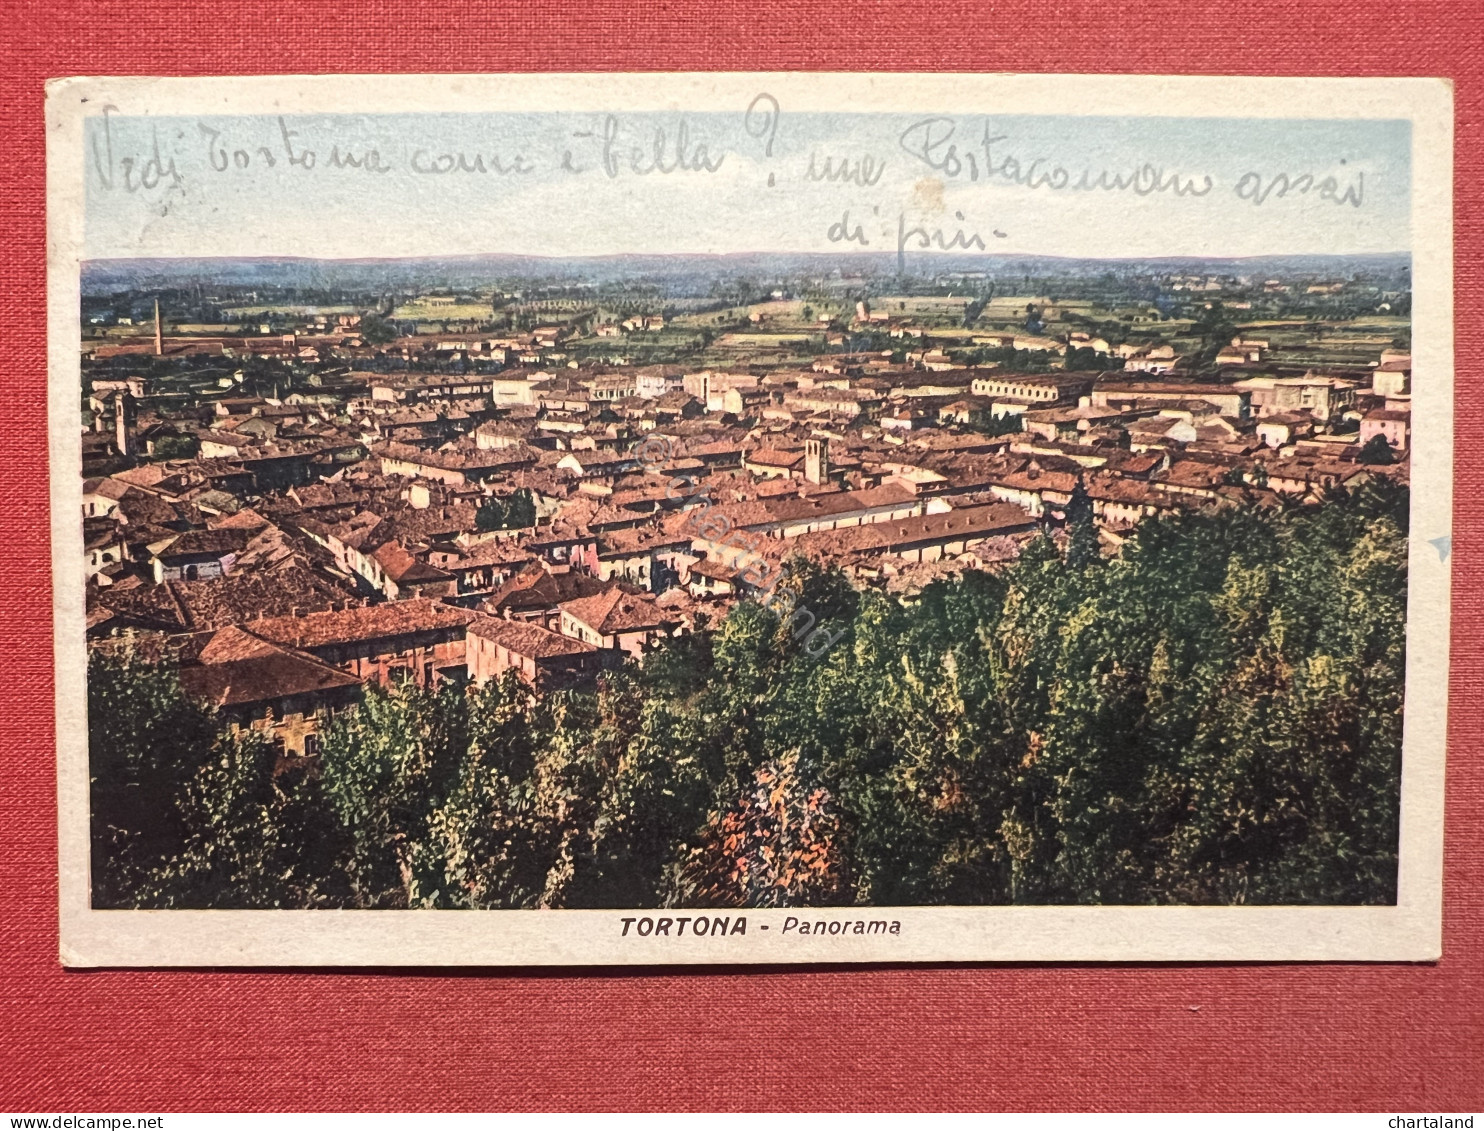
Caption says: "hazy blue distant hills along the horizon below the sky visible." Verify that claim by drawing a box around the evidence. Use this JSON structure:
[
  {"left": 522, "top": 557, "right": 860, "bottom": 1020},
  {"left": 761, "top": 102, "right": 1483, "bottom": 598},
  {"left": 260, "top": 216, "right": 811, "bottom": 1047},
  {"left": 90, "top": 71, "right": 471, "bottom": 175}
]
[{"left": 82, "top": 251, "right": 1410, "bottom": 294}]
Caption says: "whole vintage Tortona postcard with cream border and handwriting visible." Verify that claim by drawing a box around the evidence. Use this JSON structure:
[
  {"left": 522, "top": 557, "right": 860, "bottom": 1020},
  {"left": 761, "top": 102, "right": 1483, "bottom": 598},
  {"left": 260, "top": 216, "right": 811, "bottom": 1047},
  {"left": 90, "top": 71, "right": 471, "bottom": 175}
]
[{"left": 47, "top": 74, "right": 1453, "bottom": 966}]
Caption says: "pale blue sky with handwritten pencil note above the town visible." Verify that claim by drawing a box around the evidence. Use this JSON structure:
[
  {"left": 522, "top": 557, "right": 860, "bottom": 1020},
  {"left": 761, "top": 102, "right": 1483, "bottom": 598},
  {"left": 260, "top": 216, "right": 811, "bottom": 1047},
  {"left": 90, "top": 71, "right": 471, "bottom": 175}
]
[{"left": 85, "top": 113, "right": 1411, "bottom": 258}]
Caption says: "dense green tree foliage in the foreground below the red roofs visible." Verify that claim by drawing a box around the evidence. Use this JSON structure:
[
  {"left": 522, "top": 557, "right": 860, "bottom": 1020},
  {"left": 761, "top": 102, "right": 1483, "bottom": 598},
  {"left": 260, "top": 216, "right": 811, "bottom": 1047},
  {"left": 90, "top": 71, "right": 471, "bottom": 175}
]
[{"left": 91, "top": 484, "right": 1407, "bottom": 908}]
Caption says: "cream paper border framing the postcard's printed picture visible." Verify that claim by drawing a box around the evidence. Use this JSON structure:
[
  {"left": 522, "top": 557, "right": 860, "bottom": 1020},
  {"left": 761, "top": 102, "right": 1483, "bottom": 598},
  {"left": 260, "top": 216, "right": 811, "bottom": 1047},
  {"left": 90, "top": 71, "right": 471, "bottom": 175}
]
[{"left": 46, "top": 73, "right": 1453, "bottom": 966}]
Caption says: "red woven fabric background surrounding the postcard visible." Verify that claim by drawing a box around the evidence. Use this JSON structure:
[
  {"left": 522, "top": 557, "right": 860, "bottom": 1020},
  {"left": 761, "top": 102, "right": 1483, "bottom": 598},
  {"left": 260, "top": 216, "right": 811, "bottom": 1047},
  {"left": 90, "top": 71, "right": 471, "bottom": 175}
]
[{"left": 0, "top": 0, "right": 1484, "bottom": 1110}]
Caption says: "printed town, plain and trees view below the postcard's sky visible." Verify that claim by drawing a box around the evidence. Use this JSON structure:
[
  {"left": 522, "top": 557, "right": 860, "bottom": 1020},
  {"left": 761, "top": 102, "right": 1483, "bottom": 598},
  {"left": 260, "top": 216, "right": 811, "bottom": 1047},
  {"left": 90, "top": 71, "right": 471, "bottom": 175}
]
[{"left": 80, "top": 252, "right": 1411, "bottom": 908}]
